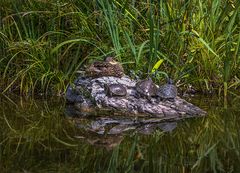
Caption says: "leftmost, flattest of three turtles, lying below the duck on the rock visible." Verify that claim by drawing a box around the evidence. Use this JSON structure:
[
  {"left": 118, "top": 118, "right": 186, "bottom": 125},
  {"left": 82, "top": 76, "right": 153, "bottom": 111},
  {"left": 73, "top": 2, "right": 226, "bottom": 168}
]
[{"left": 104, "top": 84, "right": 127, "bottom": 97}]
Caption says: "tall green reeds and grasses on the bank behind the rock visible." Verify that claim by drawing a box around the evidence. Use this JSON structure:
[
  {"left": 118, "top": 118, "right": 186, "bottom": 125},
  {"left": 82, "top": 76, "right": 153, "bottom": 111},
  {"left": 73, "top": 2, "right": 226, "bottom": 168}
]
[{"left": 0, "top": 0, "right": 240, "bottom": 95}]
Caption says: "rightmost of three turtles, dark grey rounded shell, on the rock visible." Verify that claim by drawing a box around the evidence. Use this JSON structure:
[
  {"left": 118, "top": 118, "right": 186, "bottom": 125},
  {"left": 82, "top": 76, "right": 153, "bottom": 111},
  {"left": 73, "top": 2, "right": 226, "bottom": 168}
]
[{"left": 157, "top": 78, "right": 177, "bottom": 101}]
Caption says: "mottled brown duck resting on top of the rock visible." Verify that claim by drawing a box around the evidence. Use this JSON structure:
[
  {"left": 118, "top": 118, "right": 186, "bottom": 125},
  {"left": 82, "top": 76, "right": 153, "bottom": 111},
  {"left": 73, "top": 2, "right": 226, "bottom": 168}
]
[{"left": 86, "top": 57, "right": 124, "bottom": 78}]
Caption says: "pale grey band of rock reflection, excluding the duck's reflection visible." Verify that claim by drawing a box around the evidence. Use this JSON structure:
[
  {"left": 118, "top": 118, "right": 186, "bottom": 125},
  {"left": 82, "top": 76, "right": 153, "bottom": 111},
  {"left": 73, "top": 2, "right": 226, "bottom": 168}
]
[{"left": 70, "top": 117, "right": 177, "bottom": 135}]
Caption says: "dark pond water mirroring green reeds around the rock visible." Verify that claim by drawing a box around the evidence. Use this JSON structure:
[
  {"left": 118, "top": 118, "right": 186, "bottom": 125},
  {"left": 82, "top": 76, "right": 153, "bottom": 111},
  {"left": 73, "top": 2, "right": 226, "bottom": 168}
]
[{"left": 0, "top": 96, "right": 240, "bottom": 173}]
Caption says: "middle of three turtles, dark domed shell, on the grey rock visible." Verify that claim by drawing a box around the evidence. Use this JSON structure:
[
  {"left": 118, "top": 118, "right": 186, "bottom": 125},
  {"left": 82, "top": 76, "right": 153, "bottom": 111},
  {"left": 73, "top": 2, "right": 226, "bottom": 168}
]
[{"left": 136, "top": 78, "right": 157, "bottom": 100}]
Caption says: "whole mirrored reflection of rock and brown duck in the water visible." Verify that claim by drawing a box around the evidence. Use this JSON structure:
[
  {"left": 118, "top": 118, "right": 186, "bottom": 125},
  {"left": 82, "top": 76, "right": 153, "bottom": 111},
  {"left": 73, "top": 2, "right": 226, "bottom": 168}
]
[{"left": 65, "top": 106, "right": 177, "bottom": 150}]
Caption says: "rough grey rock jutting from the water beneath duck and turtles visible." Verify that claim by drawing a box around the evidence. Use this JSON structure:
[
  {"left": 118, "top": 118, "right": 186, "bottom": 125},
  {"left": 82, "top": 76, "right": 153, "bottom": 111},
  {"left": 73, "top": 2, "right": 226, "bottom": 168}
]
[{"left": 66, "top": 76, "right": 206, "bottom": 120}]
